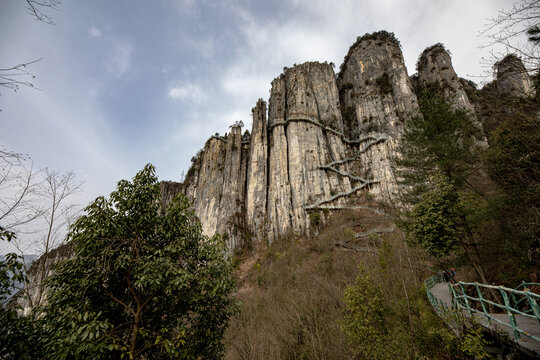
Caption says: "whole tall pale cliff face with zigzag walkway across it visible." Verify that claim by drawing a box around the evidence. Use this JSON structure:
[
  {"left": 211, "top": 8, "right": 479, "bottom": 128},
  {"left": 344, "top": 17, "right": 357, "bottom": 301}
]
[{"left": 163, "top": 31, "right": 526, "bottom": 249}]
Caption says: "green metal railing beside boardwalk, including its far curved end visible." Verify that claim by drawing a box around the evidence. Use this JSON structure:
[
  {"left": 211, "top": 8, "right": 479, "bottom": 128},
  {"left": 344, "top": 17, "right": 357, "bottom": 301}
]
[{"left": 424, "top": 275, "right": 540, "bottom": 342}]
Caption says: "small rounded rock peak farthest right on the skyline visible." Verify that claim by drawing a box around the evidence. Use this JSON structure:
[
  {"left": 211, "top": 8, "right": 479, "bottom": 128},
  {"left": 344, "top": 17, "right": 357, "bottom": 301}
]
[{"left": 494, "top": 54, "right": 534, "bottom": 97}]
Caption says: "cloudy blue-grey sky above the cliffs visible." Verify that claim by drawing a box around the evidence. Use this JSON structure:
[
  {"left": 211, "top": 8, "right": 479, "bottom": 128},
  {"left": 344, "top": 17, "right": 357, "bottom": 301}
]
[{"left": 0, "top": 0, "right": 513, "bottom": 253}]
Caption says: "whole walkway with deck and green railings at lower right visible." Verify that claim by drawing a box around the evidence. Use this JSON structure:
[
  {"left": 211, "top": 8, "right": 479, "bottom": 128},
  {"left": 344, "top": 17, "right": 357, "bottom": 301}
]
[{"left": 425, "top": 275, "right": 540, "bottom": 357}]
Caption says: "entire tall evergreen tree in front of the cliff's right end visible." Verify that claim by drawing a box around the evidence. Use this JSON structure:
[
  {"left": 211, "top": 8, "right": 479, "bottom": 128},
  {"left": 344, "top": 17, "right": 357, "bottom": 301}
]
[{"left": 393, "top": 91, "right": 486, "bottom": 282}]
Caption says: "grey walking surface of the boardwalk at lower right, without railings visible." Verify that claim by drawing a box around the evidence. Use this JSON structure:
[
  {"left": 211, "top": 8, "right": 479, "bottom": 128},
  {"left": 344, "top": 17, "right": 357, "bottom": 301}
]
[{"left": 430, "top": 282, "right": 540, "bottom": 357}]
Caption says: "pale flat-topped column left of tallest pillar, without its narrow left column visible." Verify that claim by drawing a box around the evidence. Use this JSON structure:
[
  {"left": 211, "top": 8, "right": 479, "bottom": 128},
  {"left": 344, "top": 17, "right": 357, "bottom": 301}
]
[{"left": 285, "top": 62, "right": 350, "bottom": 233}]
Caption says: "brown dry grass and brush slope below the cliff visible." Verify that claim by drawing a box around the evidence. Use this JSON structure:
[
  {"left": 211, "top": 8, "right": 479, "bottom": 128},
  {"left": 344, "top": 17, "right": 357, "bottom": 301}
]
[{"left": 225, "top": 210, "right": 456, "bottom": 360}]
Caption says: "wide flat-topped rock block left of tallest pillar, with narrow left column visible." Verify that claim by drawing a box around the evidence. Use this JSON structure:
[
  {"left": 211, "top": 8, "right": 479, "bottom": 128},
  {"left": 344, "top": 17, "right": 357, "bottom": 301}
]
[{"left": 267, "top": 62, "right": 351, "bottom": 239}]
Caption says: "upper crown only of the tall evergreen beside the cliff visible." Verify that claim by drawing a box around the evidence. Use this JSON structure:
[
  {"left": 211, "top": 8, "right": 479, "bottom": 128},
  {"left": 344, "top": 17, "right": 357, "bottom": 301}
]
[{"left": 394, "top": 92, "right": 481, "bottom": 205}]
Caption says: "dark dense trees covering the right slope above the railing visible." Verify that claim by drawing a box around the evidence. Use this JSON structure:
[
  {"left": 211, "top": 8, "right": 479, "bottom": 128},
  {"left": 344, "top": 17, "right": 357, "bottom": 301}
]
[{"left": 394, "top": 70, "right": 540, "bottom": 286}]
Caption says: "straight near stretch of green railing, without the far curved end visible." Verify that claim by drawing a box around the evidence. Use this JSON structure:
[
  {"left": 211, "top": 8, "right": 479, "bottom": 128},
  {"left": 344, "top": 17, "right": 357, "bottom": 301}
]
[{"left": 450, "top": 281, "right": 540, "bottom": 341}]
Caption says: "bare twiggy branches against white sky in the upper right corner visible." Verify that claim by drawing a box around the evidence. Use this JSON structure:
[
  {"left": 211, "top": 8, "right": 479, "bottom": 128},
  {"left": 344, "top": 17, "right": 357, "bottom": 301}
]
[{"left": 480, "top": 0, "right": 540, "bottom": 72}]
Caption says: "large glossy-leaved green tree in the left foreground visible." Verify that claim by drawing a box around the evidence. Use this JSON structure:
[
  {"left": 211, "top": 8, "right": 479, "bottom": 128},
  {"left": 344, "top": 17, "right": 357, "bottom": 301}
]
[{"left": 41, "top": 165, "right": 235, "bottom": 359}]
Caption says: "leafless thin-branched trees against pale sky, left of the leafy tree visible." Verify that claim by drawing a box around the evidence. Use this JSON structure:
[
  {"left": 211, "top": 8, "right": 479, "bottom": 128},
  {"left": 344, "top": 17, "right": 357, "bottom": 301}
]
[{"left": 0, "top": 147, "right": 82, "bottom": 309}]
